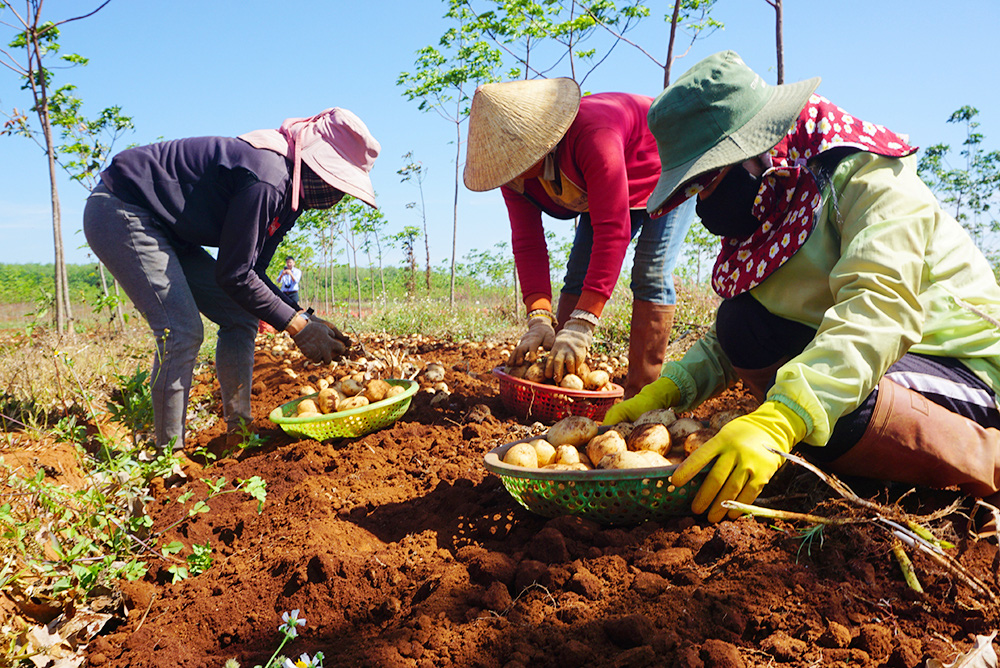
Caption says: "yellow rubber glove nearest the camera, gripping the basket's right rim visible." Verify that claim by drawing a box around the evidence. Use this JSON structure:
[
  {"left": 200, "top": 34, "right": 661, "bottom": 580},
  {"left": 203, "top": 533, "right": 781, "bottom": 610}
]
[{"left": 670, "top": 401, "right": 806, "bottom": 522}]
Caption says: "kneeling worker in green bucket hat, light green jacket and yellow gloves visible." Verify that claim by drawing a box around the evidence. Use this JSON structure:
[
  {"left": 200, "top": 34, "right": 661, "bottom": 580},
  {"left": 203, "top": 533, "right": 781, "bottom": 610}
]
[{"left": 606, "top": 51, "right": 1000, "bottom": 522}]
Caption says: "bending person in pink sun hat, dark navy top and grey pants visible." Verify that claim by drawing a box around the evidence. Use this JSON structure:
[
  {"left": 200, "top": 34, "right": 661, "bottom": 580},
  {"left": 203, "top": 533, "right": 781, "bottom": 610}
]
[{"left": 83, "top": 108, "right": 379, "bottom": 449}]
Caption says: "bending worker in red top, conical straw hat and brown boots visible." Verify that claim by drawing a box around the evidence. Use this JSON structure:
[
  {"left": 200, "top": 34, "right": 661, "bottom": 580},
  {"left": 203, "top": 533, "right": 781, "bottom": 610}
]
[{"left": 465, "top": 79, "right": 693, "bottom": 397}]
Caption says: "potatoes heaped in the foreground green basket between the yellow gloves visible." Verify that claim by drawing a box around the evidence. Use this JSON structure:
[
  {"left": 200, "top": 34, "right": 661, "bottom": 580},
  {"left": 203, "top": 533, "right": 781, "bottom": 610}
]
[{"left": 503, "top": 409, "right": 741, "bottom": 471}]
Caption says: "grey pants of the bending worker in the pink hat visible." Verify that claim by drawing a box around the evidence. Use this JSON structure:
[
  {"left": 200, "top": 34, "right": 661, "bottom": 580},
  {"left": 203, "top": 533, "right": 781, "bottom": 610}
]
[{"left": 83, "top": 184, "right": 257, "bottom": 450}]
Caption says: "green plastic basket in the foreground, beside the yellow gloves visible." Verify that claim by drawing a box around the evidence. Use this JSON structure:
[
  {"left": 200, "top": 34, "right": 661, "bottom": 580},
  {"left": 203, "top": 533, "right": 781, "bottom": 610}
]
[{"left": 484, "top": 434, "right": 705, "bottom": 524}]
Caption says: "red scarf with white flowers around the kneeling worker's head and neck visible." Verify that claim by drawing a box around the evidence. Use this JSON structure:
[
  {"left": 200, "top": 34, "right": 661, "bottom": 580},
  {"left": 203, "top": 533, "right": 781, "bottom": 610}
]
[{"left": 712, "top": 95, "right": 917, "bottom": 299}]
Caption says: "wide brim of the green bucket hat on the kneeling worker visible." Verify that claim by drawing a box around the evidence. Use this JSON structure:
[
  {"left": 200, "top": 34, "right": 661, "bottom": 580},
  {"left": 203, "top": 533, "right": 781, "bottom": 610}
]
[{"left": 646, "top": 77, "right": 820, "bottom": 213}]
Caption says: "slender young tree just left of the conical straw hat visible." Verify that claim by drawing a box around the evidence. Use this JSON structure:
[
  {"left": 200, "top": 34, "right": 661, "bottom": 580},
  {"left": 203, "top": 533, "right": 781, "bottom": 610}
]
[{"left": 396, "top": 5, "right": 501, "bottom": 308}]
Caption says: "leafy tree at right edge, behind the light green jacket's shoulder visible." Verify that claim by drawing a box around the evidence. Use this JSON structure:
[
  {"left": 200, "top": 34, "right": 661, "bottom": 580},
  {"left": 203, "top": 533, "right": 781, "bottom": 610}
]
[{"left": 917, "top": 106, "right": 1000, "bottom": 265}]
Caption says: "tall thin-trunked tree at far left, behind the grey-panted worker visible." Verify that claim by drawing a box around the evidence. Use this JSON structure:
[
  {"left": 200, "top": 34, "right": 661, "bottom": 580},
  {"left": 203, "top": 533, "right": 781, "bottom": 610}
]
[{"left": 0, "top": 0, "right": 111, "bottom": 333}]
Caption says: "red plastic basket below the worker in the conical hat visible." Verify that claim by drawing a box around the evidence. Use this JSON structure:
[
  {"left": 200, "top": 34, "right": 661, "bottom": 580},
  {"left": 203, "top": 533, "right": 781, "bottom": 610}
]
[{"left": 493, "top": 367, "right": 625, "bottom": 422}]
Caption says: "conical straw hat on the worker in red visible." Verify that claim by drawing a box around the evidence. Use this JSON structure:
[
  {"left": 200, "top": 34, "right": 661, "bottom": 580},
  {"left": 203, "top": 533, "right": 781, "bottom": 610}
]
[{"left": 465, "top": 78, "right": 580, "bottom": 191}]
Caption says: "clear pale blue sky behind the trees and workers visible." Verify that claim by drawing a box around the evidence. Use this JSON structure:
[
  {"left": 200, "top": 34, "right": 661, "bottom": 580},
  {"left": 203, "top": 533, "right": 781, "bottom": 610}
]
[{"left": 0, "top": 0, "right": 1000, "bottom": 265}]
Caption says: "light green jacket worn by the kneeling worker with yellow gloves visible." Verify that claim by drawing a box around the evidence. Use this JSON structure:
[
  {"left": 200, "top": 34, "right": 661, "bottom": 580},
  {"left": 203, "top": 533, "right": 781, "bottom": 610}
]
[{"left": 662, "top": 152, "right": 1000, "bottom": 446}]
